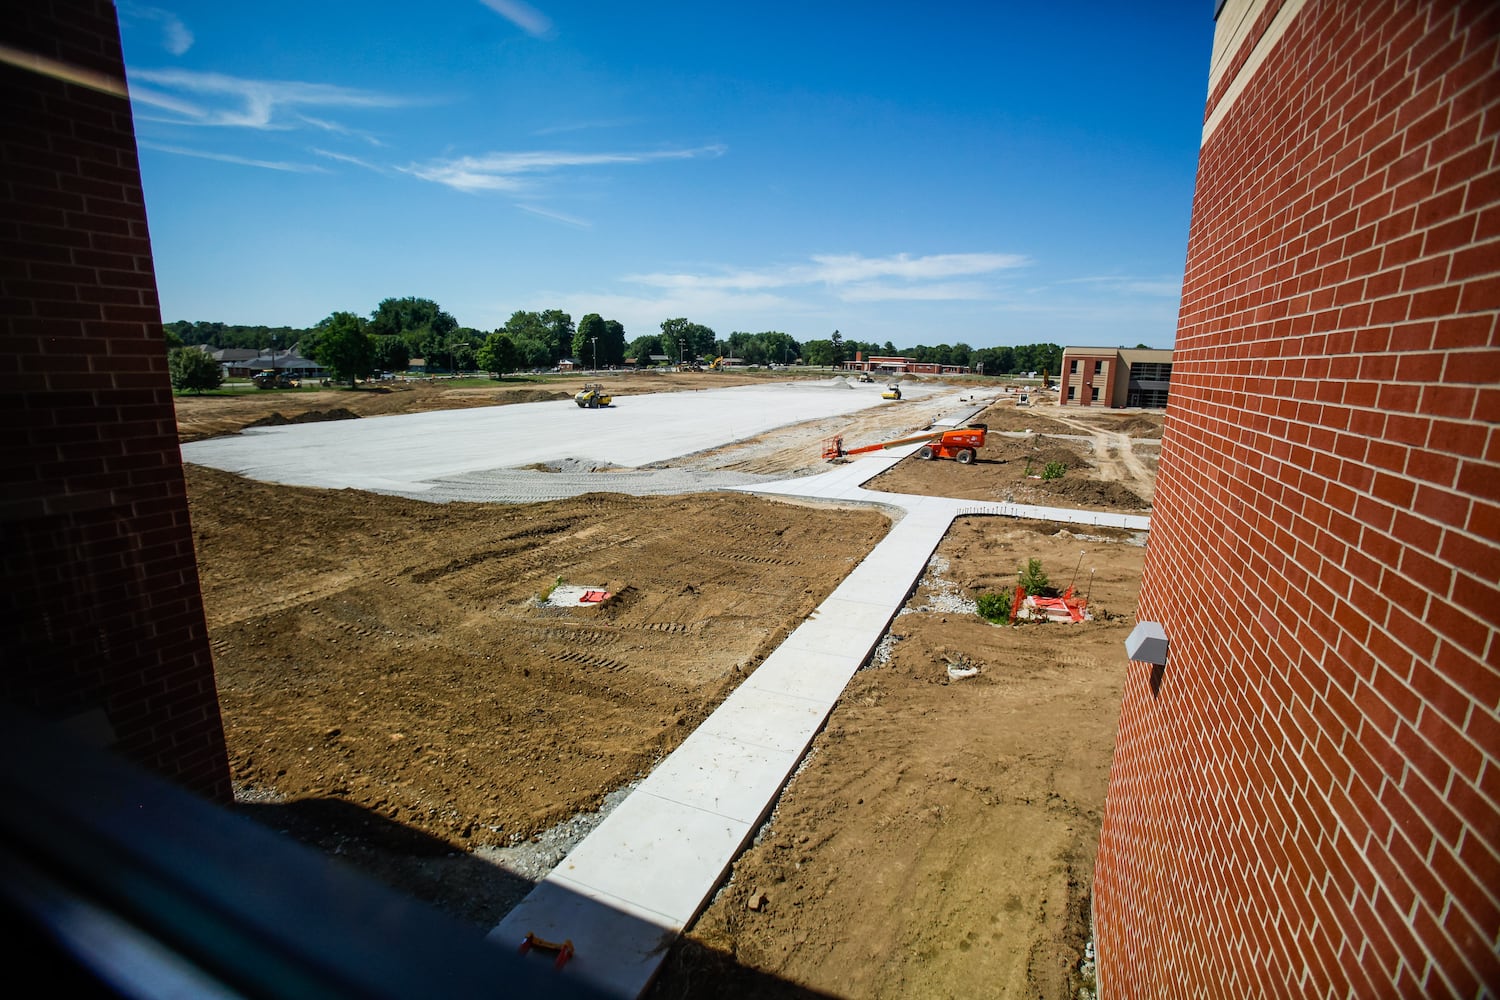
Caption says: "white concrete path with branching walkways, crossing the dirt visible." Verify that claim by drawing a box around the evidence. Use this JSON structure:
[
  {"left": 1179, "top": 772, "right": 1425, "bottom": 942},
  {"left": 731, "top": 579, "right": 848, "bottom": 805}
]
[{"left": 489, "top": 417, "right": 1149, "bottom": 997}]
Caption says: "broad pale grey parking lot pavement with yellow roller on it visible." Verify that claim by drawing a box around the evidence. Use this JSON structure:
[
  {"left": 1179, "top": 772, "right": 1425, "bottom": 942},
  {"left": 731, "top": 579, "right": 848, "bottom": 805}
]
[{"left": 183, "top": 382, "right": 924, "bottom": 495}]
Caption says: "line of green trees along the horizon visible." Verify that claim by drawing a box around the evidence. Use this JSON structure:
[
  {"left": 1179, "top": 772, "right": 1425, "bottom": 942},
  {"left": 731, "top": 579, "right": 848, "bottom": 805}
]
[{"left": 164, "top": 297, "right": 1062, "bottom": 384}]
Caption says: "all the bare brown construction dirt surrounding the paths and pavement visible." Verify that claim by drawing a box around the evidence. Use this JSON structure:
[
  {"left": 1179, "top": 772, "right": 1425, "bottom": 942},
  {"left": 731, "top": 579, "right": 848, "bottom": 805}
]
[{"left": 179, "top": 373, "right": 1161, "bottom": 997}]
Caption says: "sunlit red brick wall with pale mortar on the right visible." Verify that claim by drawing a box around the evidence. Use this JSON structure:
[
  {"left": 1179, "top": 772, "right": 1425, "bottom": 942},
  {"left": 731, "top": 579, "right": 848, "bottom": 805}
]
[{"left": 1094, "top": 0, "right": 1500, "bottom": 1000}]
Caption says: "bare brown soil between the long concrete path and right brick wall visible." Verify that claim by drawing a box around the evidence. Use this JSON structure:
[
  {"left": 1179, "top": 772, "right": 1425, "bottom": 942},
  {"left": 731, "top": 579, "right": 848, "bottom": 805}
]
[{"left": 654, "top": 517, "right": 1143, "bottom": 997}]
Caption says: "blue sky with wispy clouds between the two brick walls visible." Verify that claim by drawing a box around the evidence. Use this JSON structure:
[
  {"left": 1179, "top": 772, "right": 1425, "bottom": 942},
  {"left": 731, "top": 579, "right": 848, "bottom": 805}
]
[{"left": 117, "top": 0, "right": 1214, "bottom": 348}]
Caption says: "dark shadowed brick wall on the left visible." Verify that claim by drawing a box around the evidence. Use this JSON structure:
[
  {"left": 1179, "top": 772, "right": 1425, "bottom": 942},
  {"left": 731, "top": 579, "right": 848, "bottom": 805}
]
[{"left": 0, "top": 0, "right": 230, "bottom": 799}]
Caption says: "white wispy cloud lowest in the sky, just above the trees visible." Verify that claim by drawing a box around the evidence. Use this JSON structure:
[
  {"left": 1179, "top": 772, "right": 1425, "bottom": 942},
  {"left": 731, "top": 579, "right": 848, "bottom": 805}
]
[{"left": 626, "top": 253, "right": 1031, "bottom": 301}]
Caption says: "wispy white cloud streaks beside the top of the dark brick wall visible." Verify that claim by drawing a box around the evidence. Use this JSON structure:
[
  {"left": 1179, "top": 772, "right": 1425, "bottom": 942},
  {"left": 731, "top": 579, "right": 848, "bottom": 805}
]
[{"left": 131, "top": 69, "right": 416, "bottom": 133}]
